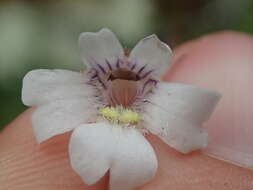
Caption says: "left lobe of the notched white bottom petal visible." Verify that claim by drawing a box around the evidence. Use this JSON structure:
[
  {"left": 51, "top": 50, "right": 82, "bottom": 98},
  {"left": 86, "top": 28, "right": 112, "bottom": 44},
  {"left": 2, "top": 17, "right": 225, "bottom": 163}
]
[{"left": 69, "top": 123, "right": 115, "bottom": 185}]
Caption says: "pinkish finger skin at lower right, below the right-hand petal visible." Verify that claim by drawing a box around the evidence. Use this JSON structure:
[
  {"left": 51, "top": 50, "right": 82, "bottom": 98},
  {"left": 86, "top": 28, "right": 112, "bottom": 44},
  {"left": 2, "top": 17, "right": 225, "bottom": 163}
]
[{"left": 141, "top": 135, "right": 253, "bottom": 190}]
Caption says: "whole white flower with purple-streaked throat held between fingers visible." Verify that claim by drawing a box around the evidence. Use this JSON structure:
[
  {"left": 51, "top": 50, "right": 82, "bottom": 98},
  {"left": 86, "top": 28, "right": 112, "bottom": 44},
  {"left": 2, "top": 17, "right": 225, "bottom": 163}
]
[{"left": 22, "top": 29, "right": 220, "bottom": 190}]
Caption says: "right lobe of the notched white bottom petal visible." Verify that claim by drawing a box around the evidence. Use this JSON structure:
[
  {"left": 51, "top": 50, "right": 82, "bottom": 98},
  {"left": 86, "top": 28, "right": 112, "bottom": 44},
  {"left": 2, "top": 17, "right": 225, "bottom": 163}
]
[{"left": 110, "top": 129, "right": 157, "bottom": 190}]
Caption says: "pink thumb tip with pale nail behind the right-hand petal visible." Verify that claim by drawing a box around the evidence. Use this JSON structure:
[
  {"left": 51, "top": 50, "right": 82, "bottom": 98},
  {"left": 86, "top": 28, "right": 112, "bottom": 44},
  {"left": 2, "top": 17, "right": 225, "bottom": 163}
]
[{"left": 165, "top": 32, "right": 253, "bottom": 168}]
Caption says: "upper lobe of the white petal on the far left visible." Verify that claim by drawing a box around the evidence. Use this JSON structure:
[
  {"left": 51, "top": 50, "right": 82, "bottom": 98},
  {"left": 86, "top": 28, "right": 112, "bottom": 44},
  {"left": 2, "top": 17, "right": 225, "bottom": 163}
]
[{"left": 22, "top": 69, "right": 94, "bottom": 106}]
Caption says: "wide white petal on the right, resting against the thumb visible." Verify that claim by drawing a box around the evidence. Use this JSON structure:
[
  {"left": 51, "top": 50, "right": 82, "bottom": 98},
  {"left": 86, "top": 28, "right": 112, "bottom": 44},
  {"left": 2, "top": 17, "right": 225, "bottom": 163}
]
[{"left": 143, "top": 83, "right": 220, "bottom": 153}]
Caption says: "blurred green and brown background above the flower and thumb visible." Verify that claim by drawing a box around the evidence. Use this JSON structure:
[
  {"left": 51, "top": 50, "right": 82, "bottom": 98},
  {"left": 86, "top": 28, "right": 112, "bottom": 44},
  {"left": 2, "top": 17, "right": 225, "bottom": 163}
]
[{"left": 0, "top": 0, "right": 253, "bottom": 129}]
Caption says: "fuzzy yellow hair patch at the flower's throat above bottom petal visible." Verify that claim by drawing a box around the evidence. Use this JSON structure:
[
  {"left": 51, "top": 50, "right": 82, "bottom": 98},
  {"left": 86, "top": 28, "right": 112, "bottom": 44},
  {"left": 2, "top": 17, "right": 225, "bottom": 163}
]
[{"left": 99, "top": 107, "right": 140, "bottom": 124}]
